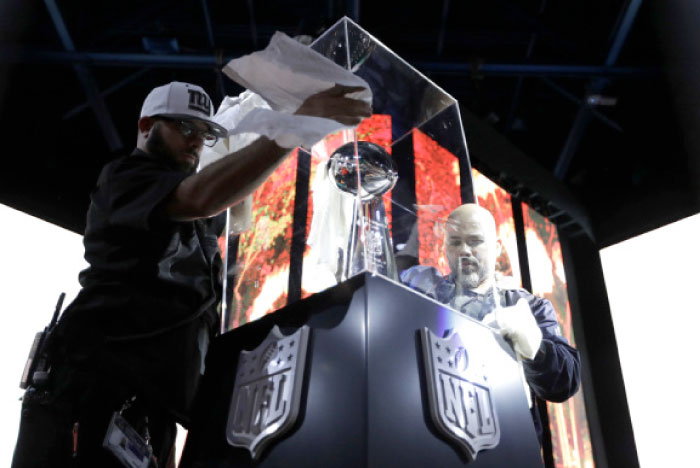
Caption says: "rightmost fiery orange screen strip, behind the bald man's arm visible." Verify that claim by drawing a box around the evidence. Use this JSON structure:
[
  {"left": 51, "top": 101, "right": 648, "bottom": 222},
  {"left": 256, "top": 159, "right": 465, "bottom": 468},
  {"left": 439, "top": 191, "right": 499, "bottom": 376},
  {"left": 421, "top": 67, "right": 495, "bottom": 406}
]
[{"left": 523, "top": 205, "right": 595, "bottom": 468}]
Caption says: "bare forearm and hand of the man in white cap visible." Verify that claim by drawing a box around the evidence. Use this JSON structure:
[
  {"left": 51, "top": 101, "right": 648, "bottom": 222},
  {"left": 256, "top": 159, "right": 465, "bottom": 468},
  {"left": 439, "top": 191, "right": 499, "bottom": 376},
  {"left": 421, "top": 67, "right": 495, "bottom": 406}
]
[{"left": 165, "top": 85, "right": 372, "bottom": 221}]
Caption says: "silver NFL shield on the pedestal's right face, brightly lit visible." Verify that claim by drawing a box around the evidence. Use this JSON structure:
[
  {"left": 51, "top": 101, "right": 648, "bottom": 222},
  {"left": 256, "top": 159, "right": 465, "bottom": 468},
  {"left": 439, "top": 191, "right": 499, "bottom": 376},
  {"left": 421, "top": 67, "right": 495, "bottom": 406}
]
[{"left": 421, "top": 328, "right": 500, "bottom": 460}]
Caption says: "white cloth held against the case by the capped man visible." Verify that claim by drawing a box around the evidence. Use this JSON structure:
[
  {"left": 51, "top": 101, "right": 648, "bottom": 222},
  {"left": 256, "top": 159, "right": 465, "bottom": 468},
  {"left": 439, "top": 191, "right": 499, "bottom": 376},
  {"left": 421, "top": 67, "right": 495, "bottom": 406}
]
[{"left": 223, "top": 32, "right": 372, "bottom": 148}]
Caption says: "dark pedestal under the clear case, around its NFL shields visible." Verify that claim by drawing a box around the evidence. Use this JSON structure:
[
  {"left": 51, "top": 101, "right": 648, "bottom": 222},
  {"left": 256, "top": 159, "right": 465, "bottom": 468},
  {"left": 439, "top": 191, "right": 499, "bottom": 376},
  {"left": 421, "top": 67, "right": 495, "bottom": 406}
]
[{"left": 181, "top": 274, "right": 542, "bottom": 468}]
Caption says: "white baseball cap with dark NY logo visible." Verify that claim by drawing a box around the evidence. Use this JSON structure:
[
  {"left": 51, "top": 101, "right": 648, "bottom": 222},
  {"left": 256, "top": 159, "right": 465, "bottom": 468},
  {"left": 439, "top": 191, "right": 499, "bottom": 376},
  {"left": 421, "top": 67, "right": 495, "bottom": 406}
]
[{"left": 141, "top": 81, "right": 228, "bottom": 138}]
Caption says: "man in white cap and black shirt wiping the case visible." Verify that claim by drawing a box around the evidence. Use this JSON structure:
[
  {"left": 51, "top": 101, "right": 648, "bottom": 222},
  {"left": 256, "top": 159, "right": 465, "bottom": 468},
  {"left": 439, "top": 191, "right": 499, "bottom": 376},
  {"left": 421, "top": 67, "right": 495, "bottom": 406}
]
[{"left": 12, "top": 82, "right": 371, "bottom": 468}]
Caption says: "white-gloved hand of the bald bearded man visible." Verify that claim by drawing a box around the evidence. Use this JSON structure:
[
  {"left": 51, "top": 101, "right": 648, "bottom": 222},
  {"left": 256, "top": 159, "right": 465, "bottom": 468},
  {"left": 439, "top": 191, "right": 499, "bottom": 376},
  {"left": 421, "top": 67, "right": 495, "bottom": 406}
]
[{"left": 482, "top": 299, "right": 542, "bottom": 359}]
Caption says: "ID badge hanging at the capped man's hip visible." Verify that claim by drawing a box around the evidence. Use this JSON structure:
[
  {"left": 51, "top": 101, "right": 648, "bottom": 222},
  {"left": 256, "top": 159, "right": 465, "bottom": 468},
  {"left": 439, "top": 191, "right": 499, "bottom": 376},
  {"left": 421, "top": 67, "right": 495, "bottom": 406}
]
[{"left": 102, "top": 412, "right": 153, "bottom": 468}]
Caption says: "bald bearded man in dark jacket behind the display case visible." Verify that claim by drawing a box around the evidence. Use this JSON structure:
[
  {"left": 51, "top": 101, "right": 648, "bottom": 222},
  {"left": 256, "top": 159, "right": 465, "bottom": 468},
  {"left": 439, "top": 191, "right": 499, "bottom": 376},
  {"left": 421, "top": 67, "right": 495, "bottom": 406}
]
[{"left": 401, "top": 203, "right": 581, "bottom": 438}]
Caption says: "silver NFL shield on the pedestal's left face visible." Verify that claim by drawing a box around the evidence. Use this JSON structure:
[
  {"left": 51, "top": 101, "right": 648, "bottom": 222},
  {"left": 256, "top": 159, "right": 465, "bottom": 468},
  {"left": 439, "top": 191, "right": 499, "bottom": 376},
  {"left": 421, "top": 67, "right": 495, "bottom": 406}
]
[{"left": 226, "top": 325, "right": 309, "bottom": 459}]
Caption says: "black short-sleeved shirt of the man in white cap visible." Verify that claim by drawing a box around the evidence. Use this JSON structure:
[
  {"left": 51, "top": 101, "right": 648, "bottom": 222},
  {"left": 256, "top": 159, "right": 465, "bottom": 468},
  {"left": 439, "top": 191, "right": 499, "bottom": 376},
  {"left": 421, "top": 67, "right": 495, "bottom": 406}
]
[{"left": 56, "top": 150, "right": 224, "bottom": 417}]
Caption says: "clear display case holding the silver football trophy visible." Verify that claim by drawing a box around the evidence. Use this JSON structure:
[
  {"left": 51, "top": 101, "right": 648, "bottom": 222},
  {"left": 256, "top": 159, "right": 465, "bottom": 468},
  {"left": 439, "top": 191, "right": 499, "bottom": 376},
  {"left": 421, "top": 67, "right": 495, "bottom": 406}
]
[{"left": 222, "top": 18, "right": 474, "bottom": 330}]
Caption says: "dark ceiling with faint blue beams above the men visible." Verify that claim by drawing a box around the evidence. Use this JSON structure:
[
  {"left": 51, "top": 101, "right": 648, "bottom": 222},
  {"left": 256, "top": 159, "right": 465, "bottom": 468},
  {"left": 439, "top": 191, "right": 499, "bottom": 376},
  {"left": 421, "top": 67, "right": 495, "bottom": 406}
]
[{"left": 0, "top": 0, "right": 700, "bottom": 246}]
